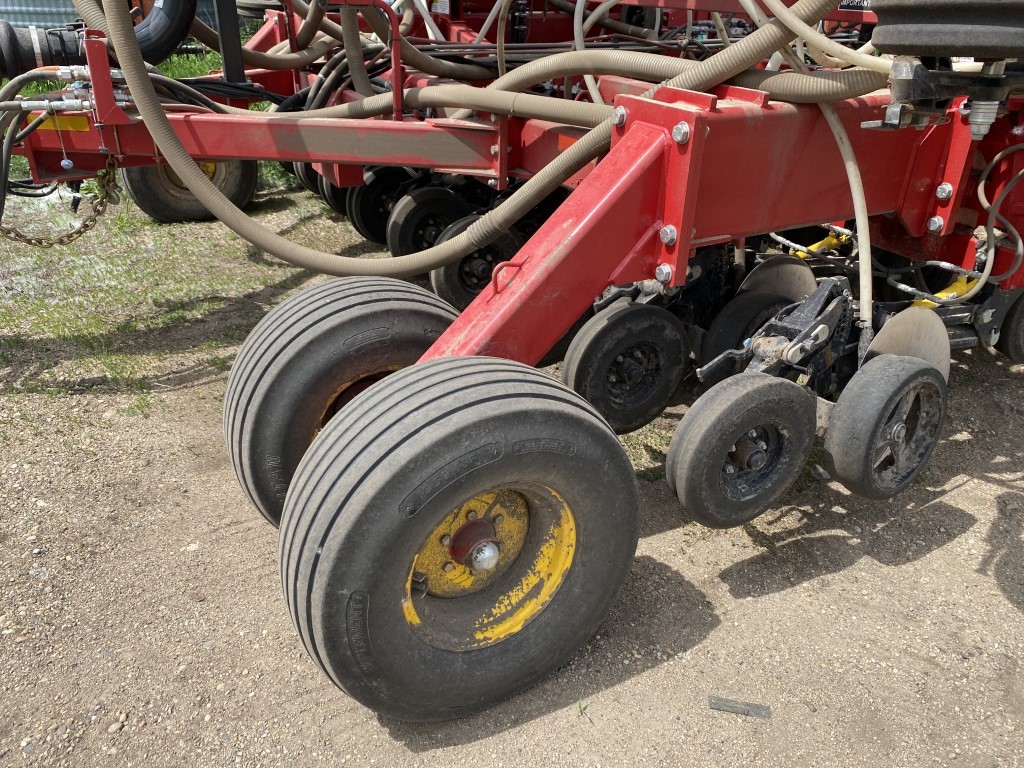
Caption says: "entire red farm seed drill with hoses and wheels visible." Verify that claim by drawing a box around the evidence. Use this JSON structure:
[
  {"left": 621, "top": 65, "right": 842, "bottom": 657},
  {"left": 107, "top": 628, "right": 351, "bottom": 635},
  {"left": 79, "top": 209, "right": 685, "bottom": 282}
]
[{"left": 0, "top": 0, "right": 1024, "bottom": 720}]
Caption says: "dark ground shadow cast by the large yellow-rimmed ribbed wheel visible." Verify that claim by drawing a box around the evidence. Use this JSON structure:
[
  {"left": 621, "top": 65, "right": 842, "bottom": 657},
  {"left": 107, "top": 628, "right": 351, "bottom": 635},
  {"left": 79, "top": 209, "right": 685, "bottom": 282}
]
[{"left": 380, "top": 556, "right": 721, "bottom": 762}]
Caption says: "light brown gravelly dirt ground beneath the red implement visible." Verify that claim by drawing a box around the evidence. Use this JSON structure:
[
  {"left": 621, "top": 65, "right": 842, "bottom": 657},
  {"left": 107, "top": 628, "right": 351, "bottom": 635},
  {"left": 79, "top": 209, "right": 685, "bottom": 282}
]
[{"left": 0, "top": 186, "right": 1024, "bottom": 768}]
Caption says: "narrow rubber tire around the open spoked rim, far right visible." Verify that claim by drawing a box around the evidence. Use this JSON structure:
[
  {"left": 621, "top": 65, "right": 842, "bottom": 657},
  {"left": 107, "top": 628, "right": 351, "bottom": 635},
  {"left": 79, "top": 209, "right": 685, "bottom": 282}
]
[{"left": 823, "top": 354, "right": 946, "bottom": 500}]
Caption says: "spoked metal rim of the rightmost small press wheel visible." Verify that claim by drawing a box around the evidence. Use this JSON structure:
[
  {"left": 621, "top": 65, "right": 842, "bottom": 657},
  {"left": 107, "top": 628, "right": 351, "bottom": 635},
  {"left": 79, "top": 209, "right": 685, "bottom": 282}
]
[{"left": 870, "top": 380, "right": 942, "bottom": 489}]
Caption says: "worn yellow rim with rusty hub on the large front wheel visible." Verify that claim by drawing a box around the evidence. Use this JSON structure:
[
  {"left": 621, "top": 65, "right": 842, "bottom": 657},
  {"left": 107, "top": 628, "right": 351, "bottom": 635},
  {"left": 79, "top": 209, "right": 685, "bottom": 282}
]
[{"left": 401, "top": 484, "right": 577, "bottom": 650}]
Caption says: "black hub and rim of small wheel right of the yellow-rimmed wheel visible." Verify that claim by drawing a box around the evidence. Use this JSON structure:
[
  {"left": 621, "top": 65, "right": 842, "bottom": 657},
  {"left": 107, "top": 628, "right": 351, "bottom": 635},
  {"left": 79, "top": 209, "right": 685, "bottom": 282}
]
[{"left": 722, "top": 422, "right": 793, "bottom": 502}]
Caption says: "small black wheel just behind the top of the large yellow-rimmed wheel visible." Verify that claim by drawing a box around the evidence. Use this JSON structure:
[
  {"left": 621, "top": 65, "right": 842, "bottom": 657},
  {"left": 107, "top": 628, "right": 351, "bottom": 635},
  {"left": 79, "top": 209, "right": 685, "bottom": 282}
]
[{"left": 562, "top": 301, "right": 689, "bottom": 434}]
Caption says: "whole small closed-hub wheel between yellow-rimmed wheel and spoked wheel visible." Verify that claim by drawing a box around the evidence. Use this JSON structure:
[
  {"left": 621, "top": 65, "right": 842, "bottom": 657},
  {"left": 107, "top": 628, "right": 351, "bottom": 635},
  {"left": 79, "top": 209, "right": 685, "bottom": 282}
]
[{"left": 665, "top": 373, "right": 816, "bottom": 528}]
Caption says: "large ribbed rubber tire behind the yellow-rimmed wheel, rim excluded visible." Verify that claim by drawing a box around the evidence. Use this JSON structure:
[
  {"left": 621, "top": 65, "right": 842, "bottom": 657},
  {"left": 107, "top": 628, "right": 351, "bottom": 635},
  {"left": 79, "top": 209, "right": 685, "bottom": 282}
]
[{"left": 224, "top": 278, "right": 456, "bottom": 525}]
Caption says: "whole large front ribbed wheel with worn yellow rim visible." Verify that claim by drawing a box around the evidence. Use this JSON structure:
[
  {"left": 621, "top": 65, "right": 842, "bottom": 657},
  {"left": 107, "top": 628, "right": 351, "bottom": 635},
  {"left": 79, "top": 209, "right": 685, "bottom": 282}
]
[{"left": 281, "top": 357, "right": 639, "bottom": 721}]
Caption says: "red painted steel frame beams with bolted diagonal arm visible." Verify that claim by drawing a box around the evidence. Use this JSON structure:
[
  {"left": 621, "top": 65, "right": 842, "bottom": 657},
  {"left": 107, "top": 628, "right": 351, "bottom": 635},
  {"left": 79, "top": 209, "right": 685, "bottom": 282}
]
[{"left": 14, "top": 12, "right": 1024, "bottom": 372}]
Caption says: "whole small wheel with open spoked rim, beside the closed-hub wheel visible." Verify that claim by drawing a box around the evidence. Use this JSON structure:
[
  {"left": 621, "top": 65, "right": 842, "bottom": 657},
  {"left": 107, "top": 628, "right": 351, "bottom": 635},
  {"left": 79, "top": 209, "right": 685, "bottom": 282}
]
[{"left": 824, "top": 354, "right": 946, "bottom": 500}]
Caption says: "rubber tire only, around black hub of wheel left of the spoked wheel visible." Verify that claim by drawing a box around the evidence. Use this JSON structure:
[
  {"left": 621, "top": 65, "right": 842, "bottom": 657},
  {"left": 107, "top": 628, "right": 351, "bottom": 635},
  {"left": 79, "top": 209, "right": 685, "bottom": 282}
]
[{"left": 665, "top": 373, "right": 816, "bottom": 528}]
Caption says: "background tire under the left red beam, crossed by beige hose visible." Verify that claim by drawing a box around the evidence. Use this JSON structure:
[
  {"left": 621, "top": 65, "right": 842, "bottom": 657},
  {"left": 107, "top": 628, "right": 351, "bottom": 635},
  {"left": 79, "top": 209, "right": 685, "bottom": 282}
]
[{"left": 121, "top": 160, "right": 259, "bottom": 224}]
